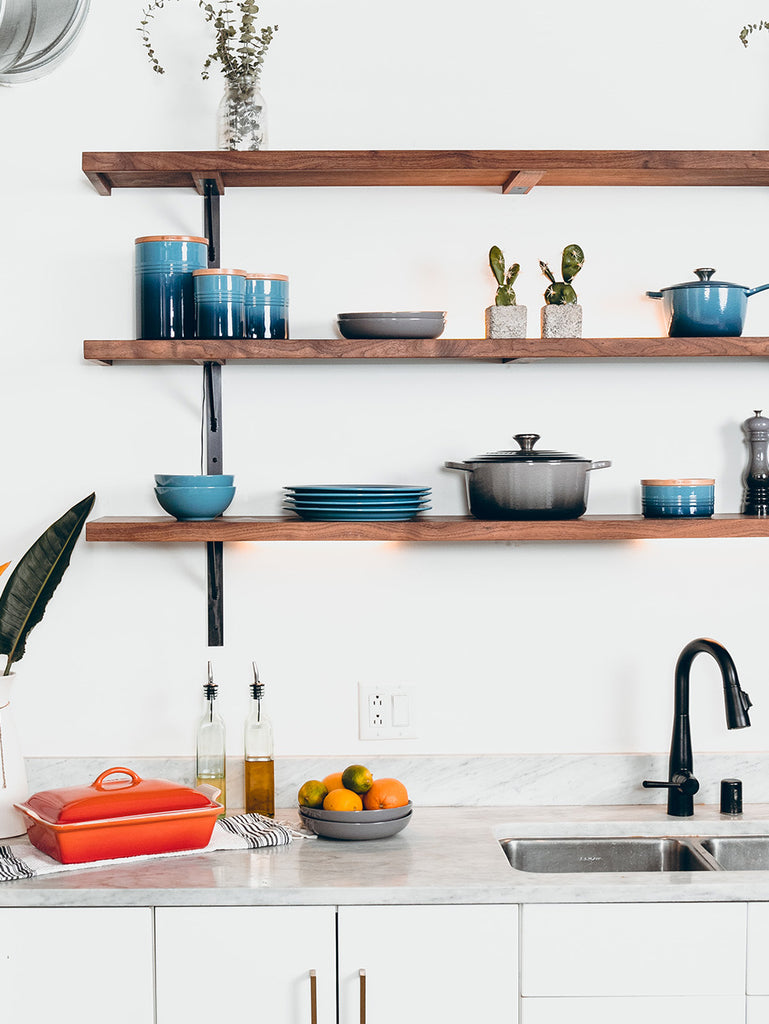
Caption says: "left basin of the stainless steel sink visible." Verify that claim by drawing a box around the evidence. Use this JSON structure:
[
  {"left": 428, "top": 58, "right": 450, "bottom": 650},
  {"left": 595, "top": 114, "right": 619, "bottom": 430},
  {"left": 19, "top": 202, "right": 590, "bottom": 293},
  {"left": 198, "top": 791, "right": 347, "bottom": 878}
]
[{"left": 500, "top": 837, "right": 720, "bottom": 873}]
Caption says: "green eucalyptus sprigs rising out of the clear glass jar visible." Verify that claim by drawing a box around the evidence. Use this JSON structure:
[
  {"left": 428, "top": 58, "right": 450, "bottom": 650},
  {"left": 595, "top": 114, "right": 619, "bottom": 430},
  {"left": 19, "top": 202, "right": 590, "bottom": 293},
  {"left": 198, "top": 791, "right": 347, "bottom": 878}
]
[{"left": 137, "top": 0, "right": 277, "bottom": 81}]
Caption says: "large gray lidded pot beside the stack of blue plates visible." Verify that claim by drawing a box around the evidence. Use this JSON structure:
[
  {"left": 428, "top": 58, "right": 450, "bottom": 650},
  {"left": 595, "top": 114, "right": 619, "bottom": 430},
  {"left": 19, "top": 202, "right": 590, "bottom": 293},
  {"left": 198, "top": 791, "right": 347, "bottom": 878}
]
[{"left": 444, "top": 434, "right": 611, "bottom": 519}]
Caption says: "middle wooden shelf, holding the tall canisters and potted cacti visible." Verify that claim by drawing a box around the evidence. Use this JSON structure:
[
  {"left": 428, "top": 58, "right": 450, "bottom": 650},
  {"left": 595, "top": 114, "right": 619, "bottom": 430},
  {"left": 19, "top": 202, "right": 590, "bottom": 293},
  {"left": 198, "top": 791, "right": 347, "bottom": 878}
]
[{"left": 83, "top": 338, "right": 769, "bottom": 365}]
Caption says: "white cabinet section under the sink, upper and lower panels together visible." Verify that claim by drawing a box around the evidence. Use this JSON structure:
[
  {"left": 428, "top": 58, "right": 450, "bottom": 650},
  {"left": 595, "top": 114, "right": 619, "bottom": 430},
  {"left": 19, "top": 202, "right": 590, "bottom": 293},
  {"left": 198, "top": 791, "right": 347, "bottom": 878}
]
[{"left": 521, "top": 903, "right": 746, "bottom": 1024}]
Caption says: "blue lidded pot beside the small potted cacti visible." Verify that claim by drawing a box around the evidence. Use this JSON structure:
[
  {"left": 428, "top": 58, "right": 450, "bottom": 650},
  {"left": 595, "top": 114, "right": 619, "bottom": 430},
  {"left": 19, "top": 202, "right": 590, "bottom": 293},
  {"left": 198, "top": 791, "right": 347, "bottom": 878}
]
[{"left": 646, "top": 267, "right": 769, "bottom": 338}]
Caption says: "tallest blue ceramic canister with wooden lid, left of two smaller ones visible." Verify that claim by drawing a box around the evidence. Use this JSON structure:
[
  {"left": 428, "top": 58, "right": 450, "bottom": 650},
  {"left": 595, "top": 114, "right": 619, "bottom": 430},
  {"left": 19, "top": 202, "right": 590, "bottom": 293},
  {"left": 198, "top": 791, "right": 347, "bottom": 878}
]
[{"left": 134, "top": 234, "right": 208, "bottom": 338}]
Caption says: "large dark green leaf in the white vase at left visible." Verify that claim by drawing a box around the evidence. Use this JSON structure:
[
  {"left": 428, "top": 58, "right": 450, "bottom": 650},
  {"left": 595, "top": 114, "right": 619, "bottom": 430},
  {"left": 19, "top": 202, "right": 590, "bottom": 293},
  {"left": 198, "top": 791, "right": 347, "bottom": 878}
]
[{"left": 0, "top": 494, "right": 96, "bottom": 676}]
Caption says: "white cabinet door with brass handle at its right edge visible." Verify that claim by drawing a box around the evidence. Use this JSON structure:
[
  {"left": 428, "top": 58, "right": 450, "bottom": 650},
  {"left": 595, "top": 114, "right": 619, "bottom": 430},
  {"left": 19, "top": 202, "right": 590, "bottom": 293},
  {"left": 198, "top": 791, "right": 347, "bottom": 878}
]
[{"left": 155, "top": 906, "right": 336, "bottom": 1024}]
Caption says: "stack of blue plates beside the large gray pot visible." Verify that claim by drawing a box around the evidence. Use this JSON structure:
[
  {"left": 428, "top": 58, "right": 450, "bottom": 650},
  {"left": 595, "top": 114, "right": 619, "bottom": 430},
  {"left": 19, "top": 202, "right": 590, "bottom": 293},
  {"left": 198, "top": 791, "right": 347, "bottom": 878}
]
[{"left": 283, "top": 483, "right": 430, "bottom": 522}]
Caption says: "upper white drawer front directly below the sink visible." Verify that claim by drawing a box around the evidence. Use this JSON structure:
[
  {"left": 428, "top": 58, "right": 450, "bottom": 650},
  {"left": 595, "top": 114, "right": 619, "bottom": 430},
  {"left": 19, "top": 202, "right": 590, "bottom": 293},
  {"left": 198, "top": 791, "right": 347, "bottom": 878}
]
[{"left": 521, "top": 903, "right": 746, "bottom": 995}]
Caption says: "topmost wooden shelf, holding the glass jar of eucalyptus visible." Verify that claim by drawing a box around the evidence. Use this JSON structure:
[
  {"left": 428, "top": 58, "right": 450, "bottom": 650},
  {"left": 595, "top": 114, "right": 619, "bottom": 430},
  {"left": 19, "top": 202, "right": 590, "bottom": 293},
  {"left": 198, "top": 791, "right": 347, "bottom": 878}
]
[{"left": 83, "top": 150, "right": 769, "bottom": 196}]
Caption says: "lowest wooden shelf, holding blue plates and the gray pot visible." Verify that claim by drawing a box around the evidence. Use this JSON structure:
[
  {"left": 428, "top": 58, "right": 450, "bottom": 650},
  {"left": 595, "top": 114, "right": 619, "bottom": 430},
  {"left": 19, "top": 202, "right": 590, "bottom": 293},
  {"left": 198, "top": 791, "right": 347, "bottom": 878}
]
[{"left": 86, "top": 514, "right": 769, "bottom": 544}]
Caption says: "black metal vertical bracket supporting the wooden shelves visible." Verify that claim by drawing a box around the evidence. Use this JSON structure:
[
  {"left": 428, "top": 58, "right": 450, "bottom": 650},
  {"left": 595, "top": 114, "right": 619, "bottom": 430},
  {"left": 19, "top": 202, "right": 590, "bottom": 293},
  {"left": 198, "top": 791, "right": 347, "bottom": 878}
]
[{"left": 201, "top": 178, "right": 224, "bottom": 647}]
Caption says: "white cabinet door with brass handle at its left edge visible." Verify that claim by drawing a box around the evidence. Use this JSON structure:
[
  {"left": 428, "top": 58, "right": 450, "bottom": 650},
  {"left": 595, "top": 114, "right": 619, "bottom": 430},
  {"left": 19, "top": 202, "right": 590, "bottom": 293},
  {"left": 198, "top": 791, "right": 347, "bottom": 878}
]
[{"left": 339, "top": 905, "right": 518, "bottom": 1024}]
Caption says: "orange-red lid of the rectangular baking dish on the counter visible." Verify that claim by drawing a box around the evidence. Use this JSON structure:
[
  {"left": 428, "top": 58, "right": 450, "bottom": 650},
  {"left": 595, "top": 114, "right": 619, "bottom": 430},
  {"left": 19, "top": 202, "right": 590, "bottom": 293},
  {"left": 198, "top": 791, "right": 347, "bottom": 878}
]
[{"left": 27, "top": 768, "right": 212, "bottom": 824}]
